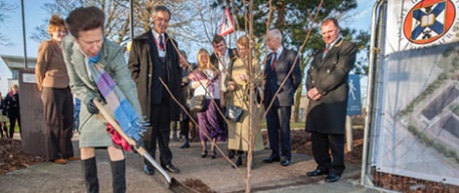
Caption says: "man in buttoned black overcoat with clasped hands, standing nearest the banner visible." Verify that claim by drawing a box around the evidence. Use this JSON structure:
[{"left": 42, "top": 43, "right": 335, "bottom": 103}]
[{"left": 306, "top": 18, "right": 357, "bottom": 182}]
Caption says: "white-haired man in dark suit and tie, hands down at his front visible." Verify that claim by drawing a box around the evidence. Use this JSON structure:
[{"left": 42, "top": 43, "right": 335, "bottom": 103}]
[{"left": 263, "top": 29, "right": 301, "bottom": 166}]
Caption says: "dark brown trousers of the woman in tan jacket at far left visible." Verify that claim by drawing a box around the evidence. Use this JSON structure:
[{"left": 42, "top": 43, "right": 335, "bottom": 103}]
[{"left": 42, "top": 87, "right": 73, "bottom": 160}]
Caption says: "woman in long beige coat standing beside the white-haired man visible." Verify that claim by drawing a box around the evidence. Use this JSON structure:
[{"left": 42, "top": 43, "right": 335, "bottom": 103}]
[{"left": 227, "top": 36, "right": 263, "bottom": 166}]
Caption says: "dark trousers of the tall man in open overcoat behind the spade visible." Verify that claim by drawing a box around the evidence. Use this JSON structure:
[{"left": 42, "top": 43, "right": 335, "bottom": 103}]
[{"left": 144, "top": 93, "right": 172, "bottom": 166}]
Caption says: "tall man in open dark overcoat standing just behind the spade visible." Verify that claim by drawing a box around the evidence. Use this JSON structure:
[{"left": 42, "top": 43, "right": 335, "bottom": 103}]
[{"left": 128, "top": 6, "right": 182, "bottom": 175}]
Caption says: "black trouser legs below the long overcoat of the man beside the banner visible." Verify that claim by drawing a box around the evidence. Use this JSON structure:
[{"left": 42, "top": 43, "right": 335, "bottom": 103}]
[{"left": 311, "top": 132, "right": 345, "bottom": 176}]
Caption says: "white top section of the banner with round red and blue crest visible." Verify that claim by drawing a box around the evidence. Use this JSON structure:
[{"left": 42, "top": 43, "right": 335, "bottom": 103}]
[{"left": 385, "top": 0, "right": 459, "bottom": 54}]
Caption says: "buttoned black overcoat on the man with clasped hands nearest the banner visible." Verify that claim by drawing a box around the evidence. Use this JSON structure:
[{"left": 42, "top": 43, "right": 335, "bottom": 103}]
[{"left": 306, "top": 40, "right": 357, "bottom": 134}]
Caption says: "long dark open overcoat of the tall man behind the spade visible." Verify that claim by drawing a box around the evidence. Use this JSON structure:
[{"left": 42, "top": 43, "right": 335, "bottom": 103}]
[{"left": 128, "top": 30, "right": 182, "bottom": 120}]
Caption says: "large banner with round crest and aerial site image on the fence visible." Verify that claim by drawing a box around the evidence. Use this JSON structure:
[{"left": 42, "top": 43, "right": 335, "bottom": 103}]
[{"left": 372, "top": 0, "right": 459, "bottom": 185}]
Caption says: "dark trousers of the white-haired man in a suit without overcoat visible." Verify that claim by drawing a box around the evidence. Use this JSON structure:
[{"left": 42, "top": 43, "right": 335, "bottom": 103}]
[{"left": 266, "top": 105, "right": 292, "bottom": 160}]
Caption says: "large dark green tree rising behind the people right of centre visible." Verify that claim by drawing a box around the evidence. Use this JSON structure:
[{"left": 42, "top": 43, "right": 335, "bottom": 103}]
[{"left": 215, "top": 0, "right": 370, "bottom": 122}]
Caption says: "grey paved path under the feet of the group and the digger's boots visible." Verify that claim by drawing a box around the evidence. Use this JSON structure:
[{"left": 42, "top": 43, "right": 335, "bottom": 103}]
[{"left": 0, "top": 136, "right": 378, "bottom": 193}]
